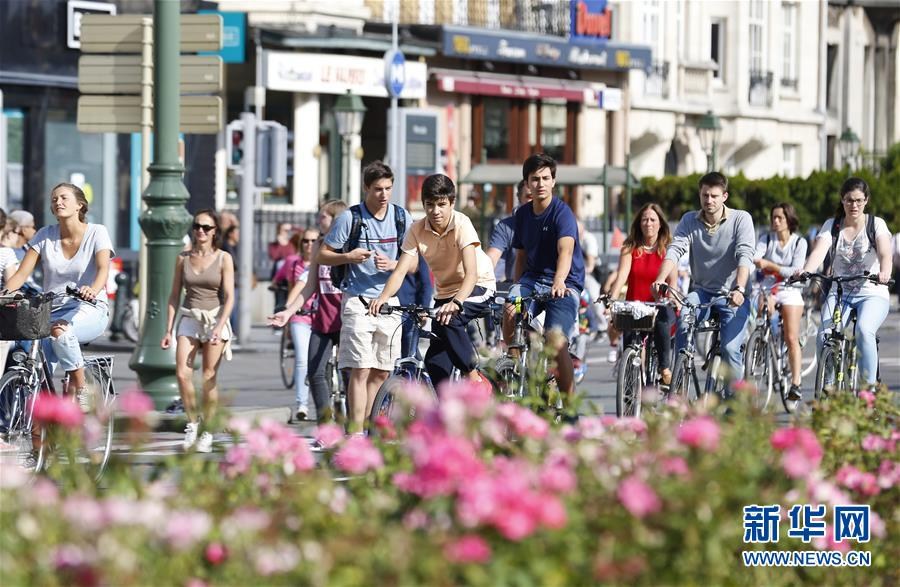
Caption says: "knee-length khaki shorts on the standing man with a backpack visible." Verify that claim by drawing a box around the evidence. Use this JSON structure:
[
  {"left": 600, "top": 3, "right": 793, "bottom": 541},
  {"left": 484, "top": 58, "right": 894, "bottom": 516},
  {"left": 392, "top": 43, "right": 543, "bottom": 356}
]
[{"left": 338, "top": 294, "right": 403, "bottom": 371}]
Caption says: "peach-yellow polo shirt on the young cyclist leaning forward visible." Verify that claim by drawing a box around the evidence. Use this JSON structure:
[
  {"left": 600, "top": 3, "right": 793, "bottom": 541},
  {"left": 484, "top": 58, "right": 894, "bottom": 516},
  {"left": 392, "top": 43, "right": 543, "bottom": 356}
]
[{"left": 400, "top": 211, "right": 497, "bottom": 299}]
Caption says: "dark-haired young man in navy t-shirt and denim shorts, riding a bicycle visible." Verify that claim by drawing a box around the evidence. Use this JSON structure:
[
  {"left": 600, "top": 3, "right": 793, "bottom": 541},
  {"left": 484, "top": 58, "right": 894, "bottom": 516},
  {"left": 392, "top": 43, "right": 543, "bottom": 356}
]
[{"left": 503, "top": 153, "right": 584, "bottom": 398}]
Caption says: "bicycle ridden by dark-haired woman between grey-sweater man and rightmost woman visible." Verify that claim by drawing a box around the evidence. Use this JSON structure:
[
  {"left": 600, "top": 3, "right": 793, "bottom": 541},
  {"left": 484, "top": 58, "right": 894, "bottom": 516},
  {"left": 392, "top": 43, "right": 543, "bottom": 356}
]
[{"left": 744, "top": 285, "right": 800, "bottom": 414}]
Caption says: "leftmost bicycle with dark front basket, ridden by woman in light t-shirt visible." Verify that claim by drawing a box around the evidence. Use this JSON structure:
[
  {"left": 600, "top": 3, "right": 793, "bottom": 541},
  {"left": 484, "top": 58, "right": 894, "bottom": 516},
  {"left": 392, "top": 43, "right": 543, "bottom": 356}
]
[{"left": 0, "top": 288, "right": 115, "bottom": 480}]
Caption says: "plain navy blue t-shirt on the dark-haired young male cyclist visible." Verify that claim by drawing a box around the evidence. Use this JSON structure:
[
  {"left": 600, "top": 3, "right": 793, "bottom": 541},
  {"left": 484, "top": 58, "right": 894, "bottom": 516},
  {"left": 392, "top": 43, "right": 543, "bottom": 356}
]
[{"left": 513, "top": 198, "right": 584, "bottom": 291}]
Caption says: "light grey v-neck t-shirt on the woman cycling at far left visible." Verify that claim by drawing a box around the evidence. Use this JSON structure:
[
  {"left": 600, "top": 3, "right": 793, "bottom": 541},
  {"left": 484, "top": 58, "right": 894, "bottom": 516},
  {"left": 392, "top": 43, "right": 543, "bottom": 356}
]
[{"left": 28, "top": 224, "right": 115, "bottom": 302}]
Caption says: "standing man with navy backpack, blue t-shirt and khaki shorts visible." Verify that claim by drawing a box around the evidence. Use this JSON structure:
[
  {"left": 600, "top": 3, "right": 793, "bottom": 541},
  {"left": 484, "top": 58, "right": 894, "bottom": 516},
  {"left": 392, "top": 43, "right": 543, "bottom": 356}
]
[{"left": 317, "top": 161, "right": 412, "bottom": 432}]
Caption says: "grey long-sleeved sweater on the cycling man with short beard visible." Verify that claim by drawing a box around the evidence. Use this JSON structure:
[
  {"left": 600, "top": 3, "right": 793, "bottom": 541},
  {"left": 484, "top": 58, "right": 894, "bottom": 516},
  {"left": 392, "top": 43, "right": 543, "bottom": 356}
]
[{"left": 666, "top": 208, "right": 756, "bottom": 294}]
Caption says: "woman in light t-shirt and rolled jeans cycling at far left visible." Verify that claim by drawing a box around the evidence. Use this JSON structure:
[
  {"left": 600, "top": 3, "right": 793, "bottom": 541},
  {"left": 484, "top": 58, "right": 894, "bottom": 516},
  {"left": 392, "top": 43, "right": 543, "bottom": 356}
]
[{"left": 5, "top": 183, "right": 114, "bottom": 404}]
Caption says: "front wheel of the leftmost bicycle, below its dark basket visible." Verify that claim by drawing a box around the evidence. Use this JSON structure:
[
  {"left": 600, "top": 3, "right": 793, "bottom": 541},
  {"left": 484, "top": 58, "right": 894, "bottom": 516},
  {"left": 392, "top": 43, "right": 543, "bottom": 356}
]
[{"left": 0, "top": 371, "right": 47, "bottom": 473}]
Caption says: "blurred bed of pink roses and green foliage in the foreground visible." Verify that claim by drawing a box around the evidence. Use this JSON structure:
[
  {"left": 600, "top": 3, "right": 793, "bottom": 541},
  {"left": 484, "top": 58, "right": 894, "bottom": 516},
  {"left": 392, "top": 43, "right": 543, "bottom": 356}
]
[{"left": 0, "top": 385, "right": 900, "bottom": 587}]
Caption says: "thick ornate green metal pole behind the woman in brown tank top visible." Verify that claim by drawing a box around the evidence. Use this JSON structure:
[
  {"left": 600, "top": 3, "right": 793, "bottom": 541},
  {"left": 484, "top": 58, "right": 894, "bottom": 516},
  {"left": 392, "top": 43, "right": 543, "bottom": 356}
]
[{"left": 128, "top": 0, "right": 191, "bottom": 409}]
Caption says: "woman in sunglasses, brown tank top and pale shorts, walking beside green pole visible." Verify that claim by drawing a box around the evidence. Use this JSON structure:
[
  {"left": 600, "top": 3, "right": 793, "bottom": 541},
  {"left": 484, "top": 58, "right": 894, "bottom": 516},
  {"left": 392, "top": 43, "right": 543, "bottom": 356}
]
[{"left": 159, "top": 209, "right": 234, "bottom": 452}]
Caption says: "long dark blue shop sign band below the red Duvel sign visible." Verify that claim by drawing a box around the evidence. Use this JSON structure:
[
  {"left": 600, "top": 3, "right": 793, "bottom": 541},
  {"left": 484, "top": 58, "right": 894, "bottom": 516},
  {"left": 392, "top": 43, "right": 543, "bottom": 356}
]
[{"left": 443, "top": 26, "right": 652, "bottom": 70}]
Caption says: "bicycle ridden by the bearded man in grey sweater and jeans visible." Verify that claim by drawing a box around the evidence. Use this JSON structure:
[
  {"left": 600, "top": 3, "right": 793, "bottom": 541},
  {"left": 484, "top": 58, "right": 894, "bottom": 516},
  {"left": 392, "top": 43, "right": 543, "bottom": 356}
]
[{"left": 659, "top": 284, "right": 726, "bottom": 402}]
